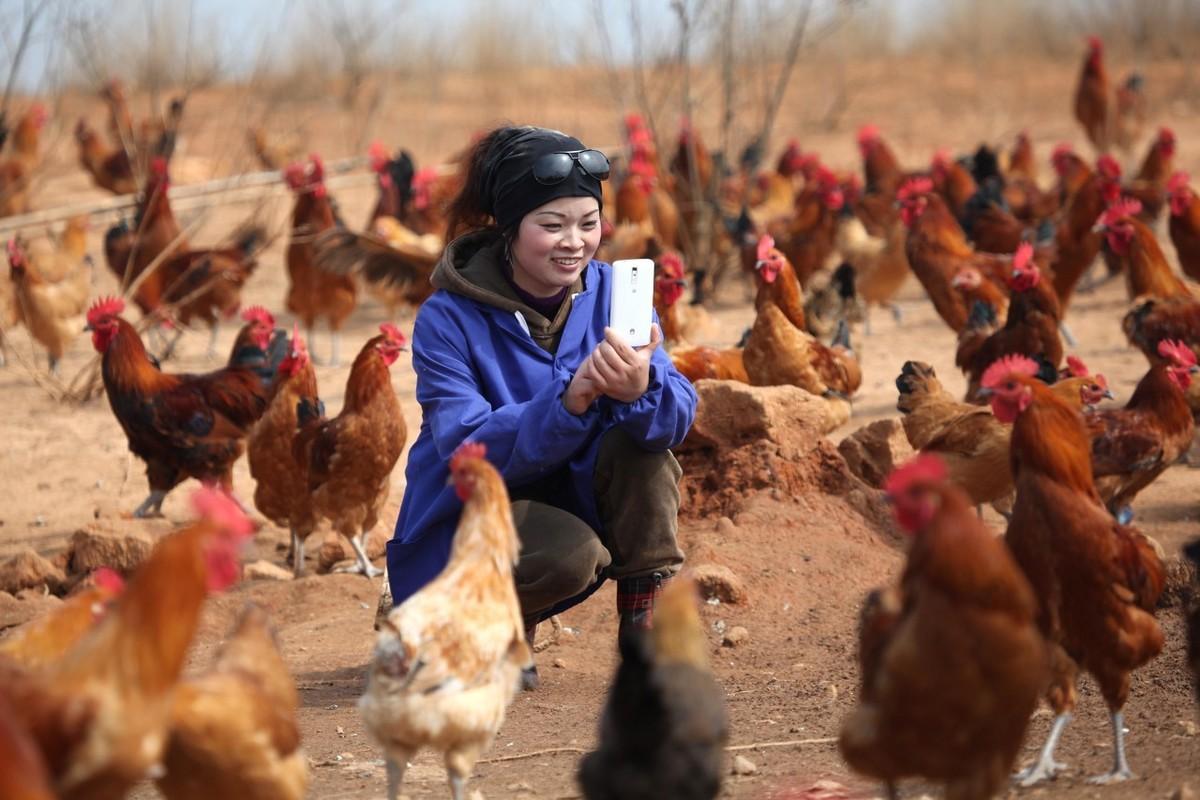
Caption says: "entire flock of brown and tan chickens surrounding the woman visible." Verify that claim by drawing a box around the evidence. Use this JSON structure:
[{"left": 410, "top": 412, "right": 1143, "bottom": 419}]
[{"left": 0, "top": 35, "right": 1200, "bottom": 800}]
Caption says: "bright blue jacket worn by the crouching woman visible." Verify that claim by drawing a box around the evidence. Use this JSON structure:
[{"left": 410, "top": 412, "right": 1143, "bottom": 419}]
[{"left": 388, "top": 250, "right": 696, "bottom": 604}]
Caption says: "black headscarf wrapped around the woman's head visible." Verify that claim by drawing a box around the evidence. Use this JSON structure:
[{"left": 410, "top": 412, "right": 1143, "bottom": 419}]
[{"left": 484, "top": 126, "right": 604, "bottom": 230}]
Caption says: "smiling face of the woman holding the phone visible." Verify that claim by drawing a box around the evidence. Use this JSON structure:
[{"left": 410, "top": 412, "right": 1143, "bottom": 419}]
[{"left": 511, "top": 197, "right": 600, "bottom": 297}]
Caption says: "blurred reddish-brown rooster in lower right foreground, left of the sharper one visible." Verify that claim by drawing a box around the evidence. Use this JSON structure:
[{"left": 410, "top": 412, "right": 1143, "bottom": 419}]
[{"left": 838, "top": 455, "right": 1046, "bottom": 800}]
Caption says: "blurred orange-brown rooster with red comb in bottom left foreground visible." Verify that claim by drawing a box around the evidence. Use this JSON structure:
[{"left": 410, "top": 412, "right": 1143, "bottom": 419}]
[{"left": 0, "top": 488, "right": 253, "bottom": 800}]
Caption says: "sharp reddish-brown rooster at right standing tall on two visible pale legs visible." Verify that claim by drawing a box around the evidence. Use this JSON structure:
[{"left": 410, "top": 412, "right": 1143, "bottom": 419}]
[{"left": 983, "top": 356, "right": 1165, "bottom": 784}]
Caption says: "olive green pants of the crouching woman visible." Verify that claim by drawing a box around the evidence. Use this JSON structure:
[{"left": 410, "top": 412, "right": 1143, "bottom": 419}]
[{"left": 511, "top": 428, "right": 683, "bottom": 620}]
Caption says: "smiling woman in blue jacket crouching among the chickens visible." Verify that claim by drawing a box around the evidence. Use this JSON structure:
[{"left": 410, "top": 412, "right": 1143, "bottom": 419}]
[{"left": 388, "top": 127, "right": 696, "bottom": 684}]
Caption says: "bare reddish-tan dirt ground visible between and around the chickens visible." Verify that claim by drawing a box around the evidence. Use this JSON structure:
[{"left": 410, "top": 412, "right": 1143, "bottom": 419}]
[{"left": 0, "top": 54, "right": 1200, "bottom": 800}]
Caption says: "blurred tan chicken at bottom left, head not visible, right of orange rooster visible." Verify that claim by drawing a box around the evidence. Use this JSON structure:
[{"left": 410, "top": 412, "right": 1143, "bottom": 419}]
[{"left": 156, "top": 606, "right": 308, "bottom": 800}]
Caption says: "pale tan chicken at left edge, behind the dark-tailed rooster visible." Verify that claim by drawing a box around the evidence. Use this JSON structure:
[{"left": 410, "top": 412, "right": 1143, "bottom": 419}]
[{"left": 8, "top": 227, "right": 92, "bottom": 373}]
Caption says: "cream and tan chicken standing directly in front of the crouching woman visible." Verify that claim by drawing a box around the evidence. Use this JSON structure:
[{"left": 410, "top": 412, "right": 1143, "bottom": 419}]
[{"left": 359, "top": 443, "right": 533, "bottom": 800}]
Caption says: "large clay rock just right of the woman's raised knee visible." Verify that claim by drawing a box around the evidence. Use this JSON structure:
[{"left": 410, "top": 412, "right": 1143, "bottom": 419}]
[{"left": 679, "top": 380, "right": 840, "bottom": 451}]
